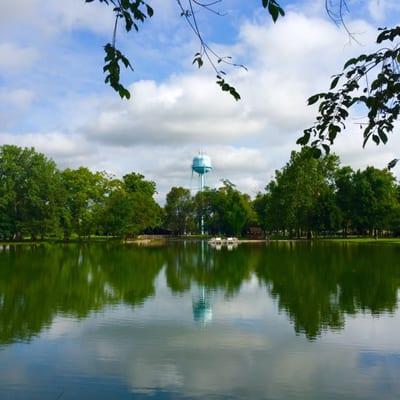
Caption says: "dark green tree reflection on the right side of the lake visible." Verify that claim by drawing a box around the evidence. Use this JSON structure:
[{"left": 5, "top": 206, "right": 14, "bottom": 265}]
[{"left": 256, "top": 242, "right": 400, "bottom": 340}]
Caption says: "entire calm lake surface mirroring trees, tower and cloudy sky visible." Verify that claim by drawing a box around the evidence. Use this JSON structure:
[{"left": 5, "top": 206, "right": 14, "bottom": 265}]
[{"left": 0, "top": 243, "right": 400, "bottom": 400}]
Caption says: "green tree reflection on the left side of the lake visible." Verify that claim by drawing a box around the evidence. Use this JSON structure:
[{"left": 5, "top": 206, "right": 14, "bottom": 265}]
[{"left": 0, "top": 245, "right": 162, "bottom": 344}]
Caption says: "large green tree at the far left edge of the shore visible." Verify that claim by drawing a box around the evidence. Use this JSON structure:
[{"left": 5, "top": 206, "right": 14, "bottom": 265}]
[{"left": 0, "top": 145, "right": 60, "bottom": 240}]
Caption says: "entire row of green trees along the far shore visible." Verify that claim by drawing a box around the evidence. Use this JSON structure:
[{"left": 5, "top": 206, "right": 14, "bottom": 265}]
[{"left": 0, "top": 145, "right": 400, "bottom": 240}]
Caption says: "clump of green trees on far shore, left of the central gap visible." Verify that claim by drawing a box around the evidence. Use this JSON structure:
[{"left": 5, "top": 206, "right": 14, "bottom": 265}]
[{"left": 0, "top": 145, "right": 161, "bottom": 240}]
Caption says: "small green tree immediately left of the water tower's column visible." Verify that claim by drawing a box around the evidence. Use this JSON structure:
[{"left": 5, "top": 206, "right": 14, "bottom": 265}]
[{"left": 165, "top": 187, "right": 195, "bottom": 235}]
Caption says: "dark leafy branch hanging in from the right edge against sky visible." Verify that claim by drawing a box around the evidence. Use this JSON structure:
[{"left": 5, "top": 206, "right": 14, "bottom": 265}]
[{"left": 297, "top": 26, "right": 400, "bottom": 168}]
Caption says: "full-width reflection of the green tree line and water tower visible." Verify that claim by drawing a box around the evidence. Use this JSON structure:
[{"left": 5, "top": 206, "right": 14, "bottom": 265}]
[{"left": 0, "top": 243, "right": 400, "bottom": 344}]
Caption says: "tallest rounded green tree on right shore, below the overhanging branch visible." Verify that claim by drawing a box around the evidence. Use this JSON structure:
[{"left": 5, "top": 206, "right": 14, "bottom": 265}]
[{"left": 265, "top": 148, "right": 339, "bottom": 238}]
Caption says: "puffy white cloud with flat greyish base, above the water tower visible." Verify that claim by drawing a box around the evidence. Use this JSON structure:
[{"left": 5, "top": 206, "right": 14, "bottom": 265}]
[{"left": 84, "top": 75, "right": 263, "bottom": 146}]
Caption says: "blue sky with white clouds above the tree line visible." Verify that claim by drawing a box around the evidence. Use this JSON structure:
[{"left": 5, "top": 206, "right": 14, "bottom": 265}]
[{"left": 0, "top": 0, "right": 400, "bottom": 203}]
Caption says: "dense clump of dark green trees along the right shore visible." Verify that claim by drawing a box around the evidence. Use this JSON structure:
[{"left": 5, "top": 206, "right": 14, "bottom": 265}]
[{"left": 254, "top": 147, "right": 400, "bottom": 238}]
